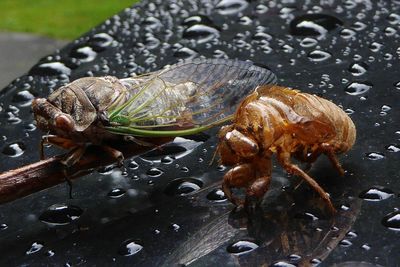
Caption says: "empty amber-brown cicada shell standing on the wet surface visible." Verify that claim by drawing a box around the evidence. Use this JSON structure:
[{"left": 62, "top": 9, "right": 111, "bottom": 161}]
[{"left": 218, "top": 85, "right": 356, "bottom": 213}]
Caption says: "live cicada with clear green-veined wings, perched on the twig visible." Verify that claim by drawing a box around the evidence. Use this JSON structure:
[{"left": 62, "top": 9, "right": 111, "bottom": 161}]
[{"left": 32, "top": 59, "right": 276, "bottom": 166}]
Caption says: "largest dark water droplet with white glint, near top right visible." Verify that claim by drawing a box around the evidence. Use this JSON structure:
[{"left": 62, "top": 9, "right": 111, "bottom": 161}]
[{"left": 290, "top": 14, "right": 343, "bottom": 36}]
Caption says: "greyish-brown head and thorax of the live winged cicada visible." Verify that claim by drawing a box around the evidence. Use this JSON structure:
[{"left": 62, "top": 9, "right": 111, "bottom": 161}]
[{"left": 32, "top": 76, "right": 129, "bottom": 143}]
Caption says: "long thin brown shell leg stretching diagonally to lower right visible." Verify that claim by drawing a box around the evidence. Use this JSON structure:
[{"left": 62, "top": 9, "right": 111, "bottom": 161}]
[{"left": 277, "top": 151, "right": 336, "bottom": 214}]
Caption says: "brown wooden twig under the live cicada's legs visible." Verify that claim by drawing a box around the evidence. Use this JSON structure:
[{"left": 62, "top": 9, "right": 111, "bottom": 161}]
[{"left": 0, "top": 138, "right": 172, "bottom": 204}]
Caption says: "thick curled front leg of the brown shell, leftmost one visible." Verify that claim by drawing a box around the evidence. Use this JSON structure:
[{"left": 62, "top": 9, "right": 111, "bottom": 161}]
[{"left": 222, "top": 163, "right": 256, "bottom": 206}]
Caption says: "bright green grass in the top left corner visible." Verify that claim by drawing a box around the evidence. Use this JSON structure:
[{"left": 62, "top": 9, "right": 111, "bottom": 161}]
[{"left": 0, "top": 0, "right": 138, "bottom": 40}]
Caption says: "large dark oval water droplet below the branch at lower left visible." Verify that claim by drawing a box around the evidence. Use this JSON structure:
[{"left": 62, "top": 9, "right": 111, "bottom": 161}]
[{"left": 39, "top": 204, "right": 83, "bottom": 225}]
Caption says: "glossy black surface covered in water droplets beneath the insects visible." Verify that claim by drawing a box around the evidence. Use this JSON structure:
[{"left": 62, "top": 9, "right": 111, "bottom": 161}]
[{"left": 0, "top": 0, "right": 400, "bottom": 266}]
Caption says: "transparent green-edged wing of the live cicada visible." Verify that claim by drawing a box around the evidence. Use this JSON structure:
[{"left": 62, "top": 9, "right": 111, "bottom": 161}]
[{"left": 108, "top": 59, "right": 276, "bottom": 136}]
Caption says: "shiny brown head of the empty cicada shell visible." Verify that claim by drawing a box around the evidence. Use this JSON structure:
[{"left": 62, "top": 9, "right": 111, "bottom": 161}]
[{"left": 218, "top": 125, "right": 259, "bottom": 165}]
